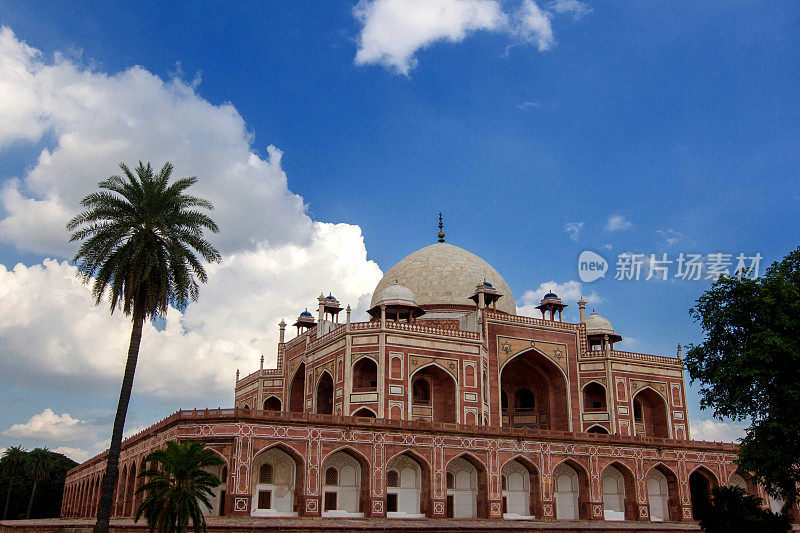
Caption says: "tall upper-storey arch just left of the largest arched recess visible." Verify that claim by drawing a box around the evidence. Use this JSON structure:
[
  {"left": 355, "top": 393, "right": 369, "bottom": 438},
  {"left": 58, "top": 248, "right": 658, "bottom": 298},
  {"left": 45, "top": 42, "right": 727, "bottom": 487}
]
[{"left": 411, "top": 364, "right": 458, "bottom": 423}]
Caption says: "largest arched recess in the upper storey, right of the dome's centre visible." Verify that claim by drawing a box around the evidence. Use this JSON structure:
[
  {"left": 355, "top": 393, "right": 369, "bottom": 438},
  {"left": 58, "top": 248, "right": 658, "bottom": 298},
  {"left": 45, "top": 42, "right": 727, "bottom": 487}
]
[{"left": 500, "top": 350, "right": 569, "bottom": 431}]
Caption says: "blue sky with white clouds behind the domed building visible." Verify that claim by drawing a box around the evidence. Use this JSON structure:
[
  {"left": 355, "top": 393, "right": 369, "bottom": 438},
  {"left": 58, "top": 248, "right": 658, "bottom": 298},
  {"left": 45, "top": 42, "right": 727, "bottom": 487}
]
[{"left": 0, "top": 0, "right": 800, "bottom": 458}]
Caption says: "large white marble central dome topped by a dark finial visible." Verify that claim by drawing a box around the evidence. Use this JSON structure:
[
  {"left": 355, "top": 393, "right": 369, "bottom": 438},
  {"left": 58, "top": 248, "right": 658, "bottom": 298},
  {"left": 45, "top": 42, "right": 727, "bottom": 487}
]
[{"left": 370, "top": 242, "right": 517, "bottom": 315}]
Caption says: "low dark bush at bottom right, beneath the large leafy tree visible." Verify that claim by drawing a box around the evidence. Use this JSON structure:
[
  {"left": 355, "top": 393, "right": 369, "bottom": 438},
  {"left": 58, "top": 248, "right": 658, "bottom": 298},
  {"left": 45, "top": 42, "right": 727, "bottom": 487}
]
[{"left": 700, "top": 487, "right": 791, "bottom": 533}]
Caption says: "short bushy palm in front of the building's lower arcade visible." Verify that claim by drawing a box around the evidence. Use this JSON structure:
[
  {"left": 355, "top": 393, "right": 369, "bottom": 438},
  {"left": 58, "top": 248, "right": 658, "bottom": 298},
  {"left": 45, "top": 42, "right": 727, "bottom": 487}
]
[{"left": 134, "top": 441, "right": 225, "bottom": 533}]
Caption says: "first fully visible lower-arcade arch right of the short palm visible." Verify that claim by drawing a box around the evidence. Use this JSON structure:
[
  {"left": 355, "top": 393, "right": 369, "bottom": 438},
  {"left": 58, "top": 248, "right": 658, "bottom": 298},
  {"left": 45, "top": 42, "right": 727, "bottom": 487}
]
[{"left": 250, "top": 445, "right": 304, "bottom": 516}]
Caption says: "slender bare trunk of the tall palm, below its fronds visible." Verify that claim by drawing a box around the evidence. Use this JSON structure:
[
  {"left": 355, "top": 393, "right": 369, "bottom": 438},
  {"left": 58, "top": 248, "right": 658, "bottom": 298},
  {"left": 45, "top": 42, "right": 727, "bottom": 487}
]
[{"left": 94, "top": 302, "right": 144, "bottom": 533}]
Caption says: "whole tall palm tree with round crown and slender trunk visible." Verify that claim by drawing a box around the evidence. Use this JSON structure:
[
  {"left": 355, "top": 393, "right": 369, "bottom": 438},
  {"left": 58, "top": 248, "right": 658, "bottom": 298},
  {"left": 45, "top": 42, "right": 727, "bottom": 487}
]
[{"left": 67, "top": 161, "right": 221, "bottom": 533}]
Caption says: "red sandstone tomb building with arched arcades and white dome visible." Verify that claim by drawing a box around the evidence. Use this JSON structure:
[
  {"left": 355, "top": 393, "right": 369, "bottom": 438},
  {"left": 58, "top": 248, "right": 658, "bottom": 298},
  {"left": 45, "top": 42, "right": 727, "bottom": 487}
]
[{"left": 57, "top": 239, "right": 792, "bottom": 521}]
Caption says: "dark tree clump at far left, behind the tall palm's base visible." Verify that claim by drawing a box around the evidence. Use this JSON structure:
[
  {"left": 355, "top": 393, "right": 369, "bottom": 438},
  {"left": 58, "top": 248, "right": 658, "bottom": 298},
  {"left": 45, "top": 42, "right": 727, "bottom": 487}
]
[{"left": 0, "top": 446, "right": 77, "bottom": 520}]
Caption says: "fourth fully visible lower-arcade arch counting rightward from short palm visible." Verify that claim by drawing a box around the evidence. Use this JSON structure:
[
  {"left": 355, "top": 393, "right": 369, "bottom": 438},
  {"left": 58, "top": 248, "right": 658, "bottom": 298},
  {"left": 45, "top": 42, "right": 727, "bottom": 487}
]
[{"left": 445, "top": 455, "right": 488, "bottom": 518}]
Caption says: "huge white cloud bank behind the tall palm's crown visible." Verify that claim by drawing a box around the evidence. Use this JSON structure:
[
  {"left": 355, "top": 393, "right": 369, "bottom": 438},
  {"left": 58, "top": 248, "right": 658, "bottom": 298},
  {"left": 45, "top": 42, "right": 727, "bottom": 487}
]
[{"left": 0, "top": 28, "right": 382, "bottom": 410}]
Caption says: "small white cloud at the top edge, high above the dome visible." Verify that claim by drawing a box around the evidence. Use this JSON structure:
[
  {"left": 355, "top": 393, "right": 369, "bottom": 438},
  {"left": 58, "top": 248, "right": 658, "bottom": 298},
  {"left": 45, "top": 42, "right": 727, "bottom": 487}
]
[{"left": 353, "top": 0, "right": 576, "bottom": 75}]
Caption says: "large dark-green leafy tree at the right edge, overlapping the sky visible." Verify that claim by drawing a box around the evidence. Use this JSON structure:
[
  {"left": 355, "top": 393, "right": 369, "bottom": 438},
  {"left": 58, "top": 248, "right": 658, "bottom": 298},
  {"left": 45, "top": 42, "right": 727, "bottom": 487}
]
[{"left": 686, "top": 248, "right": 800, "bottom": 505}]
